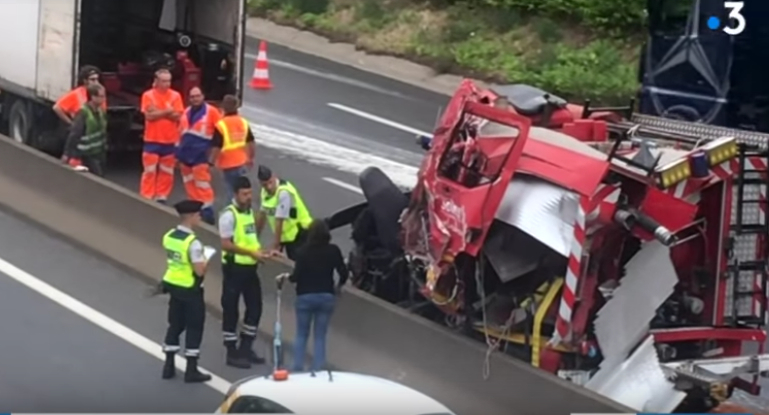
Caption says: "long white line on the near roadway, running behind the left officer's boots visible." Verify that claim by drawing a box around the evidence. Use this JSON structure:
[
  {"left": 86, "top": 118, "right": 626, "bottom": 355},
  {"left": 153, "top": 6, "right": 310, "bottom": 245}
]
[{"left": 0, "top": 258, "right": 230, "bottom": 394}]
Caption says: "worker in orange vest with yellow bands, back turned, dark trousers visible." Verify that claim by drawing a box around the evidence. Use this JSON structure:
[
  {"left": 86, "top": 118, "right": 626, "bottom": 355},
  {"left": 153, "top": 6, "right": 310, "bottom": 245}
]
[{"left": 211, "top": 95, "right": 256, "bottom": 200}]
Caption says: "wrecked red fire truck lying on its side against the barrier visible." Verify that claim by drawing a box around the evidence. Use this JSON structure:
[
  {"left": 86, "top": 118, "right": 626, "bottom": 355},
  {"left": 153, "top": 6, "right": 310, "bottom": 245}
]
[{"left": 329, "top": 81, "right": 769, "bottom": 412}]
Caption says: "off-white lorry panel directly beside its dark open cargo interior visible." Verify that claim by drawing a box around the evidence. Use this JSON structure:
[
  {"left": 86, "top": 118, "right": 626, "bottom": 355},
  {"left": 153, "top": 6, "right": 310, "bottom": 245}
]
[{"left": 35, "top": 0, "right": 77, "bottom": 101}]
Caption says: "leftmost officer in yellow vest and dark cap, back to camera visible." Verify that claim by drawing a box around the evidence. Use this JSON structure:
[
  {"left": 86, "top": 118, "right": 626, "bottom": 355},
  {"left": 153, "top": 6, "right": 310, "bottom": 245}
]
[{"left": 162, "top": 200, "right": 211, "bottom": 383}]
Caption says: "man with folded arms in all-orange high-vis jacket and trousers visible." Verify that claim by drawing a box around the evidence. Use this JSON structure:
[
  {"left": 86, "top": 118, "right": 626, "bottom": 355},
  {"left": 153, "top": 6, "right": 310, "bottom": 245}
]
[{"left": 139, "top": 69, "right": 184, "bottom": 203}]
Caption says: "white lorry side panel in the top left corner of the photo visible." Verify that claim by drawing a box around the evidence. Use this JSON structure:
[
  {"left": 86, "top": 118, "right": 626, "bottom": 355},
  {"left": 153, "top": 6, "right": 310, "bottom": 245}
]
[{"left": 0, "top": 0, "right": 40, "bottom": 90}]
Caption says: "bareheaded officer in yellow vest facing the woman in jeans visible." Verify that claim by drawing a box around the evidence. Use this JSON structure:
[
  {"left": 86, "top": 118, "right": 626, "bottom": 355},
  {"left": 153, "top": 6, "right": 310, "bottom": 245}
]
[{"left": 219, "top": 176, "right": 269, "bottom": 369}]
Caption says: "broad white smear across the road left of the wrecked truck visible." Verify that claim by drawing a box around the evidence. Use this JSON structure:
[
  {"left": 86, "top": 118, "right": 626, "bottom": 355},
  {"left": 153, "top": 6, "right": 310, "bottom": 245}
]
[{"left": 251, "top": 123, "right": 418, "bottom": 189}]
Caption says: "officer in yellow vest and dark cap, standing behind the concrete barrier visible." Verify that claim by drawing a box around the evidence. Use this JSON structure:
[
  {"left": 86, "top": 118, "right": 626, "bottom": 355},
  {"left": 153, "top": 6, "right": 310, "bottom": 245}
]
[{"left": 256, "top": 166, "right": 312, "bottom": 259}]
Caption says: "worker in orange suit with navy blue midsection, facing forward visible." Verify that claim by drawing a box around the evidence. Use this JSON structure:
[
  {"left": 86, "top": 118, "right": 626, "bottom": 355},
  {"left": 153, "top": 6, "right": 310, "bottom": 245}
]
[{"left": 176, "top": 87, "right": 222, "bottom": 225}]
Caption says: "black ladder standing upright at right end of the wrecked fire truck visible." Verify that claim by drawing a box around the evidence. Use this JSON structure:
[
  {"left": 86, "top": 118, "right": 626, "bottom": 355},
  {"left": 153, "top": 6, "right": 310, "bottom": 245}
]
[{"left": 727, "top": 144, "right": 769, "bottom": 327}]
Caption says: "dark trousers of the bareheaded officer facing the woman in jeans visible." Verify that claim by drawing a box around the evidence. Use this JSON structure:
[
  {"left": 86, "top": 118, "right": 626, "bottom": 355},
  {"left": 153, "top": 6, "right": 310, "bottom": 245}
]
[{"left": 222, "top": 264, "right": 262, "bottom": 350}]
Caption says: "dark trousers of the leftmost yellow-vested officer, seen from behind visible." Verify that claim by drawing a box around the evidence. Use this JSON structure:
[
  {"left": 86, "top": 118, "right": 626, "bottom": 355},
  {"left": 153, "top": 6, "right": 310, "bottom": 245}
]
[{"left": 163, "top": 283, "right": 206, "bottom": 358}]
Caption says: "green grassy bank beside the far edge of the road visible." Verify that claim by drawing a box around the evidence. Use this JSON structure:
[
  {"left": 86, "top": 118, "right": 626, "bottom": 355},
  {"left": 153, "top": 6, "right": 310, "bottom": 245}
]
[{"left": 249, "top": 0, "right": 645, "bottom": 104}]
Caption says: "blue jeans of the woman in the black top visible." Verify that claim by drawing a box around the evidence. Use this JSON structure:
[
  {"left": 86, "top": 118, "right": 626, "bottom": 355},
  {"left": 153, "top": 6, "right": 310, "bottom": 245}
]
[{"left": 292, "top": 293, "right": 336, "bottom": 372}]
